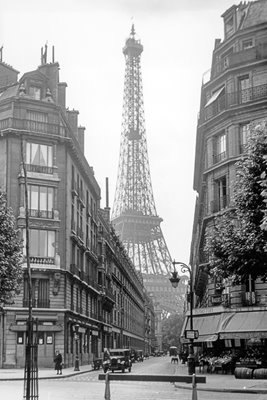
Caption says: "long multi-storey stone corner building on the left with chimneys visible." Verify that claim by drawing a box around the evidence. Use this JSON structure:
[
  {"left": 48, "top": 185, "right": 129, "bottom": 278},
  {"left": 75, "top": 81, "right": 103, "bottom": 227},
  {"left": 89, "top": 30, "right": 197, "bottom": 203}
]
[{"left": 0, "top": 49, "right": 153, "bottom": 368}]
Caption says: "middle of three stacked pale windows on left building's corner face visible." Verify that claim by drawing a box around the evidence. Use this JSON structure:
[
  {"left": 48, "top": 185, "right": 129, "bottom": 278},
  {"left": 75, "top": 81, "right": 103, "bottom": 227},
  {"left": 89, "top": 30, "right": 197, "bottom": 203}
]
[{"left": 28, "top": 185, "right": 54, "bottom": 218}]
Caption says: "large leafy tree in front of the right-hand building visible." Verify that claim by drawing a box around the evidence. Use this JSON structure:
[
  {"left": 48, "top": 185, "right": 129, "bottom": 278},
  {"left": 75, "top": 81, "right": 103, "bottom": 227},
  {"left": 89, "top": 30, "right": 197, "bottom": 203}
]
[{"left": 205, "top": 121, "right": 267, "bottom": 283}]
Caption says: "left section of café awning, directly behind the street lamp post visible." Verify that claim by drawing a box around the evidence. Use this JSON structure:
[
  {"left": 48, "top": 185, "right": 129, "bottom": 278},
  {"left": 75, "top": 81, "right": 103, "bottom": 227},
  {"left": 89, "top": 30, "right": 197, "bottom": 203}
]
[{"left": 181, "top": 313, "right": 222, "bottom": 343}]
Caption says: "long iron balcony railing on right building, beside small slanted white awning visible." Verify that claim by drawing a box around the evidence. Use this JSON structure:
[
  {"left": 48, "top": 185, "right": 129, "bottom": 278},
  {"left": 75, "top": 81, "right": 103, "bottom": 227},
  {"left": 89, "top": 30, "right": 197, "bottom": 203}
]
[{"left": 200, "top": 83, "right": 267, "bottom": 123}]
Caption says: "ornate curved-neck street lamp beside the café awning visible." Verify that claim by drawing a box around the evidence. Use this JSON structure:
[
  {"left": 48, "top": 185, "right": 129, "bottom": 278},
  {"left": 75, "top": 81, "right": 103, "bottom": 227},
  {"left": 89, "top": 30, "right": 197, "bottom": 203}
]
[{"left": 170, "top": 260, "right": 196, "bottom": 375}]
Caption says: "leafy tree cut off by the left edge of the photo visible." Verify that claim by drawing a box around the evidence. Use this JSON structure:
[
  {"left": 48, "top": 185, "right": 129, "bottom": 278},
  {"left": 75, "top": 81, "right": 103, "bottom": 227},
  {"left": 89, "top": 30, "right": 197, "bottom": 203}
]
[{"left": 0, "top": 192, "right": 22, "bottom": 305}]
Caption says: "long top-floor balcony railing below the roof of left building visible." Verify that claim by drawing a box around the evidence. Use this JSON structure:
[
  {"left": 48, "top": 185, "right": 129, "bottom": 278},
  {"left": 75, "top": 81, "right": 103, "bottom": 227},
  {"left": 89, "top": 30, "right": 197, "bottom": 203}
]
[{"left": 0, "top": 118, "right": 66, "bottom": 136}]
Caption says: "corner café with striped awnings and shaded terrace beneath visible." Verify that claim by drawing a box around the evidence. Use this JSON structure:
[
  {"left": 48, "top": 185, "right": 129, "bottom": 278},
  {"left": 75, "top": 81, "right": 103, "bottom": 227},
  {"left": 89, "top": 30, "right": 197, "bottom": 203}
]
[{"left": 181, "top": 307, "right": 267, "bottom": 373}]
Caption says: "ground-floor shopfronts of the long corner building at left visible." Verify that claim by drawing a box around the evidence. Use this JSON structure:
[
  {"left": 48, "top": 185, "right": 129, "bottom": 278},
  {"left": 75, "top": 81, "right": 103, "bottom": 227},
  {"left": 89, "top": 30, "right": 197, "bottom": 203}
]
[{"left": 0, "top": 309, "right": 147, "bottom": 368}]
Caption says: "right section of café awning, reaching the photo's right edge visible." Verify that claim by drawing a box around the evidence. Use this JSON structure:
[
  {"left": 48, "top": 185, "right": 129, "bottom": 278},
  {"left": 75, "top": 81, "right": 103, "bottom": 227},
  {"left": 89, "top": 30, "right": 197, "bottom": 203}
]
[{"left": 219, "top": 310, "right": 267, "bottom": 339}]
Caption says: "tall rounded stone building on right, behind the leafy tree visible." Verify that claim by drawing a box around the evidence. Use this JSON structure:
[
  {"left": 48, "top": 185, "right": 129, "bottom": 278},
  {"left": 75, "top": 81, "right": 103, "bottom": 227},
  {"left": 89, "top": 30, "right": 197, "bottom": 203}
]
[{"left": 187, "top": 0, "right": 267, "bottom": 354}]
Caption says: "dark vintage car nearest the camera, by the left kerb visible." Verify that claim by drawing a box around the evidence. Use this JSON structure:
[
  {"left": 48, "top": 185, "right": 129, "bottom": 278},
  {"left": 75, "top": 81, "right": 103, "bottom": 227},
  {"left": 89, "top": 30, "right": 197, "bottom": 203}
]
[{"left": 102, "top": 349, "right": 132, "bottom": 373}]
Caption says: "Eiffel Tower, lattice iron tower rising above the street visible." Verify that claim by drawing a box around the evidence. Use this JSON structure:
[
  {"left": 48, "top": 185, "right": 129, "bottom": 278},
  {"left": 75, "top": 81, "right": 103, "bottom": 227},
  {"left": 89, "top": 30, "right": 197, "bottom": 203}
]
[{"left": 112, "top": 25, "right": 182, "bottom": 312}]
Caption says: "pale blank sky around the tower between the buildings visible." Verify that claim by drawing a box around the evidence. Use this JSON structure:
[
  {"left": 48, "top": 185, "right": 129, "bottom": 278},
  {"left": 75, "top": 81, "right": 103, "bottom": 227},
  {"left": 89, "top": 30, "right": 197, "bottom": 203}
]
[{"left": 0, "top": 0, "right": 239, "bottom": 272}]
